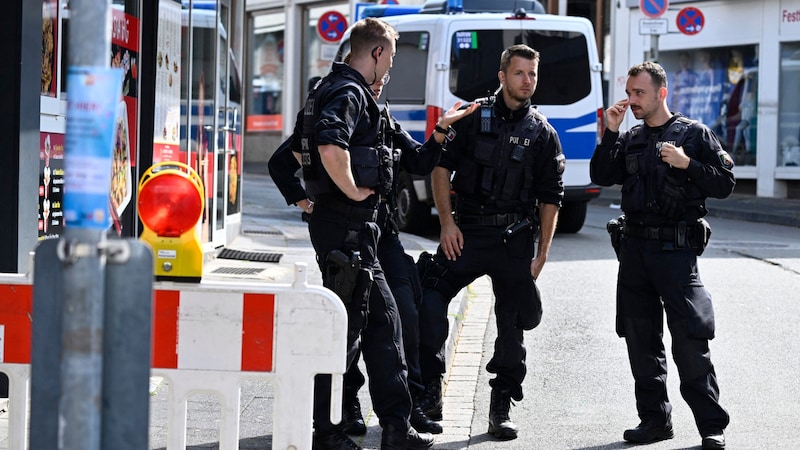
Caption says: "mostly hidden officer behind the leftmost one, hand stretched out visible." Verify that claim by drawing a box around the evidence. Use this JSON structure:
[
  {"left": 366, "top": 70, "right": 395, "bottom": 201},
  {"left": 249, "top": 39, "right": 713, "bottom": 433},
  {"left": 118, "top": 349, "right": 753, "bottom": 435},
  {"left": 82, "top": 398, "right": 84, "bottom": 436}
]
[{"left": 268, "top": 73, "right": 477, "bottom": 435}]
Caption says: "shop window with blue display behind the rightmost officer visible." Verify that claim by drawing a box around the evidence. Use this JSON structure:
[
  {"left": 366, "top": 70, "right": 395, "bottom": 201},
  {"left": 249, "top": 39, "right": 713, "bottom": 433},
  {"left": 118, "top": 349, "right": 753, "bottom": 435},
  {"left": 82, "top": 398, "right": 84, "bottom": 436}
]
[{"left": 660, "top": 45, "right": 758, "bottom": 166}]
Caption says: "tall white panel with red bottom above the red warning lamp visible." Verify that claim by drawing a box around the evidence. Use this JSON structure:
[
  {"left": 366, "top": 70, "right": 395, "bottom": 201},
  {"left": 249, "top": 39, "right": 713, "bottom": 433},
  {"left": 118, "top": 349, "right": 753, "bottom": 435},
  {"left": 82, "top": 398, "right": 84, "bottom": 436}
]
[{"left": 153, "top": 0, "right": 186, "bottom": 163}]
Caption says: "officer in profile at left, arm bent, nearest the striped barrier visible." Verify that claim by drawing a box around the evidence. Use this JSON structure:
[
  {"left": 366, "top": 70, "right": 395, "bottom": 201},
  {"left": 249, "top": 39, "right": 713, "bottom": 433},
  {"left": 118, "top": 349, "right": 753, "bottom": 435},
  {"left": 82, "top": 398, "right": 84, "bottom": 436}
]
[{"left": 300, "top": 18, "right": 433, "bottom": 449}]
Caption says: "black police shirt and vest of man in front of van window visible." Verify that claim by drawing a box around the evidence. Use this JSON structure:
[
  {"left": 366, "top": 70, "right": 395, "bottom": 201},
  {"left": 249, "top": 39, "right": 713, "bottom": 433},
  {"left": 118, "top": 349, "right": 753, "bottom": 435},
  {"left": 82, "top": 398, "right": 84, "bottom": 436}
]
[{"left": 439, "top": 95, "right": 565, "bottom": 215}]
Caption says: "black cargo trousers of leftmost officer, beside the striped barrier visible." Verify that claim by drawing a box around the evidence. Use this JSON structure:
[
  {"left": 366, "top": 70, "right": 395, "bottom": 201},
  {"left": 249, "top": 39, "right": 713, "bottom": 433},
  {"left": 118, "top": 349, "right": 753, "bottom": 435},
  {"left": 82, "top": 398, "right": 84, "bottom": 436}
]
[{"left": 308, "top": 200, "right": 411, "bottom": 433}]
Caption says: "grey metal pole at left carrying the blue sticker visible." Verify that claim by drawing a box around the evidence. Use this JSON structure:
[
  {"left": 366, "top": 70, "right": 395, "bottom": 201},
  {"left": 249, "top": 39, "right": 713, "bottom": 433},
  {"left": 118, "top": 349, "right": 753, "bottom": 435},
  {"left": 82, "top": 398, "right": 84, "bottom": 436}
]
[{"left": 58, "top": 0, "right": 111, "bottom": 450}]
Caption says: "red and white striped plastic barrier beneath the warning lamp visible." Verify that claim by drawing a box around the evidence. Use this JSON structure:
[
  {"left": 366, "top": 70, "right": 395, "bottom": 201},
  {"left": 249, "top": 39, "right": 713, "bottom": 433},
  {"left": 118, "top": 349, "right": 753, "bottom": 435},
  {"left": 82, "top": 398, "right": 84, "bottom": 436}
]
[{"left": 0, "top": 263, "right": 347, "bottom": 450}]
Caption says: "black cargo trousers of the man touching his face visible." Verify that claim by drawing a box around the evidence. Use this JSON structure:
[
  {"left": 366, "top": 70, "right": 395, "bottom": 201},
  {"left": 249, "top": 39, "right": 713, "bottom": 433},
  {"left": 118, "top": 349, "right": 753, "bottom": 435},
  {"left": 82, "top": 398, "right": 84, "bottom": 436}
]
[{"left": 617, "top": 235, "right": 730, "bottom": 435}]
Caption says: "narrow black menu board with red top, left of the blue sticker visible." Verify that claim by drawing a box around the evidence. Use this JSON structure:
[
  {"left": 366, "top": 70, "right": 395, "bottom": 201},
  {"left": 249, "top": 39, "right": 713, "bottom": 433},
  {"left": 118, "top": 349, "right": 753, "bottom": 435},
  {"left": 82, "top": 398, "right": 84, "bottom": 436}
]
[{"left": 38, "top": 133, "right": 64, "bottom": 240}]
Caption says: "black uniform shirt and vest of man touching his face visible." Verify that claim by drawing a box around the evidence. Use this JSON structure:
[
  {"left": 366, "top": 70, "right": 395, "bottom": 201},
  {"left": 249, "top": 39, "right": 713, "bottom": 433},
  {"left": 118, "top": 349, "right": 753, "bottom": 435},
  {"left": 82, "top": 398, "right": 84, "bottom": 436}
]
[{"left": 589, "top": 113, "right": 736, "bottom": 226}]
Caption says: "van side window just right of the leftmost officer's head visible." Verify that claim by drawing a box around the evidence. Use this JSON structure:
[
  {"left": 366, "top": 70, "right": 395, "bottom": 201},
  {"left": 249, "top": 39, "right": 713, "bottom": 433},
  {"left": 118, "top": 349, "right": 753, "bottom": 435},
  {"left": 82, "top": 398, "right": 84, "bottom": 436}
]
[{"left": 383, "top": 31, "right": 430, "bottom": 105}]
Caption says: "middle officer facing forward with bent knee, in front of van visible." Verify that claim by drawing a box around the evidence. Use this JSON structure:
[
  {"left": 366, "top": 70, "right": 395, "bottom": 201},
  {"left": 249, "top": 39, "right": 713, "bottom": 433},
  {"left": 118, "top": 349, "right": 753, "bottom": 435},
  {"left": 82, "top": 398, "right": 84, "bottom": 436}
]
[{"left": 418, "top": 45, "right": 565, "bottom": 439}]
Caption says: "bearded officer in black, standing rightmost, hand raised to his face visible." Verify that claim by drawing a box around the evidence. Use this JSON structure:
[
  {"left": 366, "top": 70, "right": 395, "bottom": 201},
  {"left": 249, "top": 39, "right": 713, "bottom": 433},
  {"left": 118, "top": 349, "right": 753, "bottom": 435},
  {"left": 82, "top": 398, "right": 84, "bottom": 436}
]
[{"left": 590, "top": 62, "right": 736, "bottom": 449}]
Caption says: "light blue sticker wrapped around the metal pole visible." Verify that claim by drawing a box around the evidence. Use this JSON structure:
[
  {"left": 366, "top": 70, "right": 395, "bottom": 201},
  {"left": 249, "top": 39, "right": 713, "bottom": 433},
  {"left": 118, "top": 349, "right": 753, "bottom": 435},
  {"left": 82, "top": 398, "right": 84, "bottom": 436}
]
[{"left": 64, "top": 67, "right": 123, "bottom": 230}]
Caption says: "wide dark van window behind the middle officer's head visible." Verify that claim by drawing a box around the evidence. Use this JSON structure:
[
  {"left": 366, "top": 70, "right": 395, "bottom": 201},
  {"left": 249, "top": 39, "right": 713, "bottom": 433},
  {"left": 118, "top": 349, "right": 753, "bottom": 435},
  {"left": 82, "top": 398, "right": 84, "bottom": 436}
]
[{"left": 450, "top": 30, "right": 592, "bottom": 105}]
